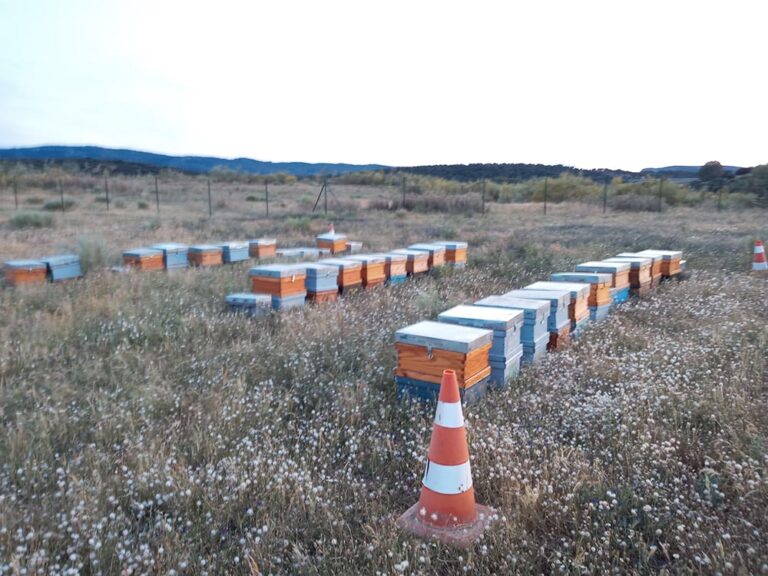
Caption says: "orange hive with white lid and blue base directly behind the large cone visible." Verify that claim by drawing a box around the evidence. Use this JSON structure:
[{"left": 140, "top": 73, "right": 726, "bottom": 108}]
[{"left": 395, "top": 322, "right": 493, "bottom": 401}]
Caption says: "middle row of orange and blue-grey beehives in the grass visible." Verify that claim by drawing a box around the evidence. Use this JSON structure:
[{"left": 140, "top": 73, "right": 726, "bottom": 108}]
[{"left": 226, "top": 234, "right": 467, "bottom": 315}]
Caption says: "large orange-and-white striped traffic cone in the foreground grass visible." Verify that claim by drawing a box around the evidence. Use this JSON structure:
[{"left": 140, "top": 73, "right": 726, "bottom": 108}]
[{"left": 397, "top": 370, "right": 493, "bottom": 547}]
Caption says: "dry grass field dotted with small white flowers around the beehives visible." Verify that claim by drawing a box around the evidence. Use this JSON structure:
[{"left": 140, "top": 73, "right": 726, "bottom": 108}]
[{"left": 0, "top": 181, "right": 768, "bottom": 575}]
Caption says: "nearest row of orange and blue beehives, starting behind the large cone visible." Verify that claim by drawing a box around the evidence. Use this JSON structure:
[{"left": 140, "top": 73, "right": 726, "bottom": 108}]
[{"left": 395, "top": 250, "right": 685, "bottom": 401}]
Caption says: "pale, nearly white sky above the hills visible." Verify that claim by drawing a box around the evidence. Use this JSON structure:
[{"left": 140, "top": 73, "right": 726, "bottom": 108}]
[{"left": 0, "top": 0, "right": 768, "bottom": 170}]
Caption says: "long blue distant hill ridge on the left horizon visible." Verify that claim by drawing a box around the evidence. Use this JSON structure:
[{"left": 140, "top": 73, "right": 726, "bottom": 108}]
[{"left": 0, "top": 146, "right": 388, "bottom": 176}]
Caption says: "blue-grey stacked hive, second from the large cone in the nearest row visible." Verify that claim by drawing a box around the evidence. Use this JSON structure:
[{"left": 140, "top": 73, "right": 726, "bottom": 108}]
[{"left": 437, "top": 305, "right": 523, "bottom": 386}]
